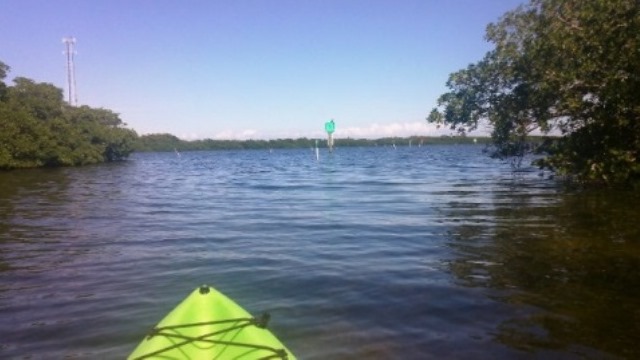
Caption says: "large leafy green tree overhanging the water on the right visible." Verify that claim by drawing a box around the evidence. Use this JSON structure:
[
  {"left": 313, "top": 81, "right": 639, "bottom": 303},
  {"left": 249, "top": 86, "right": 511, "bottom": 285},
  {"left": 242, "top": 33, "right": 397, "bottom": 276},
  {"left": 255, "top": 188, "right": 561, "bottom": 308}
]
[{"left": 428, "top": 0, "right": 640, "bottom": 184}]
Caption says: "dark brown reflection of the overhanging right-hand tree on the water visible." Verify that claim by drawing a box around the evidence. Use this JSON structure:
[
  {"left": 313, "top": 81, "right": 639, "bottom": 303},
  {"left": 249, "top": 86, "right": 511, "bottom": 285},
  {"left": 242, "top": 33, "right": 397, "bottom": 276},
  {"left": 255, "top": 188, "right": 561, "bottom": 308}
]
[{"left": 446, "top": 184, "right": 640, "bottom": 358}]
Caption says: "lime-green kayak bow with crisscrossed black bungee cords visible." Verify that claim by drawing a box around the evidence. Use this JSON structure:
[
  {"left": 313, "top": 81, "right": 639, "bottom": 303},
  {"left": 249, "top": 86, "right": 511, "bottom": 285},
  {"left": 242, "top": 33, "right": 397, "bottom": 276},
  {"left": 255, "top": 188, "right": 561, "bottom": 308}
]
[{"left": 129, "top": 286, "right": 295, "bottom": 360}]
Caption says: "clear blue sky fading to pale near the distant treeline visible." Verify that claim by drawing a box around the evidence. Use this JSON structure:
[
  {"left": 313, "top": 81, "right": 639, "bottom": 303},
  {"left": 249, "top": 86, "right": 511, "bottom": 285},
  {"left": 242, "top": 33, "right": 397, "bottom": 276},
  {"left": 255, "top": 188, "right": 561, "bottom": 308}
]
[{"left": 0, "top": 0, "right": 524, "bottom": 139}]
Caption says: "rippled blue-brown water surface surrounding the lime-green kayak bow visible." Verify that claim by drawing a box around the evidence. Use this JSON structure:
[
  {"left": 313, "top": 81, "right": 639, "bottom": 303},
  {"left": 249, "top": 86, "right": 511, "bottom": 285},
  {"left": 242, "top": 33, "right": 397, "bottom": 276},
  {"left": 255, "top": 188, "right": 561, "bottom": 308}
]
[{"left": 0, "top": 146, "right": 640, "bottom": 359}]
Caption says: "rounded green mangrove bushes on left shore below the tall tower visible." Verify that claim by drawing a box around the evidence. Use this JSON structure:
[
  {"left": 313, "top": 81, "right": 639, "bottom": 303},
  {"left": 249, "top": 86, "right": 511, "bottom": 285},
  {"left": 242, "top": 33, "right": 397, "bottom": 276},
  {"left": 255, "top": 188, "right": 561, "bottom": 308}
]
[{"left": 0, "top": 62, "right": 137, "bottom": 169}]
